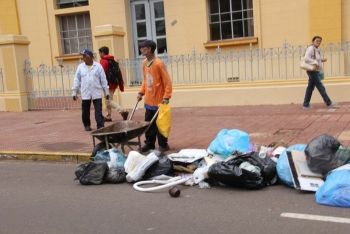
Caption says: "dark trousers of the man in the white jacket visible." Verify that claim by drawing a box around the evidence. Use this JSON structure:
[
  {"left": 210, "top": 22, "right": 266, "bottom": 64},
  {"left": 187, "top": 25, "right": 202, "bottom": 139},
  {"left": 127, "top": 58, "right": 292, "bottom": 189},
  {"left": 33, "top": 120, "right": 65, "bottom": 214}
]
[{"left": 81, "top": 98, "right": 104, "bottom": 128}]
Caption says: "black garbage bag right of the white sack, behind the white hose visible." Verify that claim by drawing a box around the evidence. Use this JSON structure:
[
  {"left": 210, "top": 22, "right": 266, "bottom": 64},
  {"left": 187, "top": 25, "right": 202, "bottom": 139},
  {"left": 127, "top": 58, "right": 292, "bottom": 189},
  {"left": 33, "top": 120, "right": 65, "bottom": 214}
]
[{"left": 143, "top": 156, "right": 173, "bottom": 179}]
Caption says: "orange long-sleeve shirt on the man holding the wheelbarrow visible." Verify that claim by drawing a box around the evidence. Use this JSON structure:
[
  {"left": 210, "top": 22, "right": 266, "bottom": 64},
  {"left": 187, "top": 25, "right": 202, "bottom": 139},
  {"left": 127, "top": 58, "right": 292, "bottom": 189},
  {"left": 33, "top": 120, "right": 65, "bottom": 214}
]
[{"left": 140, "top": 58, "right": 172, "bottom": 106}]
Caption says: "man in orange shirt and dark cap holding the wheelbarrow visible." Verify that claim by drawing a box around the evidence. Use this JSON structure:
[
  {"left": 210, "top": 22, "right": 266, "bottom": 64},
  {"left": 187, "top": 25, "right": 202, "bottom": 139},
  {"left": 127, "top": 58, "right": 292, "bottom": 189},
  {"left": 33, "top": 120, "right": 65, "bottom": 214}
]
[{"left": 137, "top": 40, "right": 172, "bottom": 153}]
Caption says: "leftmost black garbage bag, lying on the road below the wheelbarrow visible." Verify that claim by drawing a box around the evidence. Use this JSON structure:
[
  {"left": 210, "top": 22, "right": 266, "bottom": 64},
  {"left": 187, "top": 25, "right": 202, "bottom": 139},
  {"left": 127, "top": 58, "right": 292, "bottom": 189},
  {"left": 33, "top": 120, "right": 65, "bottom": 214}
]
[{"left": 75, "top": 161, "right": 108, "bottom": 185}]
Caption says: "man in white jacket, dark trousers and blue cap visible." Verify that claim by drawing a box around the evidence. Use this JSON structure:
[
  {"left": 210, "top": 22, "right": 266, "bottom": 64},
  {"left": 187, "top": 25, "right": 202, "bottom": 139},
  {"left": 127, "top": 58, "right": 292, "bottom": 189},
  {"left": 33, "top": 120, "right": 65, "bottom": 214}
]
[{"left": 72, "top": 49, "right": 109, "bottom": 131}]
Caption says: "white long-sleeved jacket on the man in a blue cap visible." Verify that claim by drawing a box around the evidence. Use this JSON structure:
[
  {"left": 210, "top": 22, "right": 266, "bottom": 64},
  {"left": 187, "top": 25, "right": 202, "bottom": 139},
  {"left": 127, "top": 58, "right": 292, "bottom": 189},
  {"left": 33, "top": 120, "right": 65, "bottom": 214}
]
[{"left": 72, "top": 61, "right": 109, "bottom": 100}]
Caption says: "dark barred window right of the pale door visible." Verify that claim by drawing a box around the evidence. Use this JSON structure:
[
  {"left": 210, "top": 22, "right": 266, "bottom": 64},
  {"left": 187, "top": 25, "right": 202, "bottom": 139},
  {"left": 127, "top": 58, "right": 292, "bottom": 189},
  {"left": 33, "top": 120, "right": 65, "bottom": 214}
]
[{"left": 209, "top": 0, "right": 254, "bottom": 41}]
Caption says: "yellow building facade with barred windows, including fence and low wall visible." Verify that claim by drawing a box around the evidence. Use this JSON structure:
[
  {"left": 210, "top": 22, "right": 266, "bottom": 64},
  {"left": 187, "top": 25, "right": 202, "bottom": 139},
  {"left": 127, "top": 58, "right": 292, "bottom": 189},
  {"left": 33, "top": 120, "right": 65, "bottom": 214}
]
[{"left": 0, "top": 0, "right": 350, "bottom": 111}]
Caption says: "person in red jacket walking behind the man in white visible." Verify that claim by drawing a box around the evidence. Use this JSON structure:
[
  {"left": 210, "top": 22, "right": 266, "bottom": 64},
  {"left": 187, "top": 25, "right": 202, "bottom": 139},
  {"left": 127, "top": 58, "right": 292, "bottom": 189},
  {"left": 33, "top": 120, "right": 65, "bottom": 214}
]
[{"left": 98, "top": 46, "right": 128, "bottom": 122}]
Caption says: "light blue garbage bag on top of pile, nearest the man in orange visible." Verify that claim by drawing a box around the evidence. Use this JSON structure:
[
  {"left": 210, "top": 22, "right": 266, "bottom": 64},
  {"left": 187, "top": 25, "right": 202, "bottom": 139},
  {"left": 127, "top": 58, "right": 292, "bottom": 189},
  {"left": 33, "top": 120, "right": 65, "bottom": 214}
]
[{"left": 208, "top": 129, "right": 250, "bottom": 158}]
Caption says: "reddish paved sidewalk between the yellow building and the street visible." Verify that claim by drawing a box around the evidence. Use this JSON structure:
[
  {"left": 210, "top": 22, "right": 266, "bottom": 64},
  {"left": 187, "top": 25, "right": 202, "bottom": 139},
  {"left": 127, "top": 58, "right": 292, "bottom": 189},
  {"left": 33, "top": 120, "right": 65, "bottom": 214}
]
[{"left": 0, "top": 103, "right": 350, "bottom": 161}]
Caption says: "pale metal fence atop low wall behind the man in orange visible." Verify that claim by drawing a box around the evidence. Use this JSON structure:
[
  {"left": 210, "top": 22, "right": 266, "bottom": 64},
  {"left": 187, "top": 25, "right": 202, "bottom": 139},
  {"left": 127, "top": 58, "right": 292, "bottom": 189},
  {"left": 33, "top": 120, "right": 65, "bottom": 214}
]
[{"left": 122, "top": 42, "right": 350, "bottom": 85}]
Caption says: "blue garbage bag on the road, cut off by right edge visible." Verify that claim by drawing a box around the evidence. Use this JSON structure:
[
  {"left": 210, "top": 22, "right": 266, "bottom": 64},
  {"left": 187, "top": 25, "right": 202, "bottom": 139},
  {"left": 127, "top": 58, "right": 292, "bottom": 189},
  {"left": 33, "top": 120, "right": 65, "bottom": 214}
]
[{"left": 315, "top": 164, "right": 350, "bottom": 208}]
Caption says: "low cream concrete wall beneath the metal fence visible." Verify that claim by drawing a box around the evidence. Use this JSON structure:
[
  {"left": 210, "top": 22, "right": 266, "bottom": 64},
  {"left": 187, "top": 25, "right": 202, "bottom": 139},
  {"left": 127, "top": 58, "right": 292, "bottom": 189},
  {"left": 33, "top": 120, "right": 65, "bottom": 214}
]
[{"left": 117, "top": 77, "right": 350, "bottom": 108}]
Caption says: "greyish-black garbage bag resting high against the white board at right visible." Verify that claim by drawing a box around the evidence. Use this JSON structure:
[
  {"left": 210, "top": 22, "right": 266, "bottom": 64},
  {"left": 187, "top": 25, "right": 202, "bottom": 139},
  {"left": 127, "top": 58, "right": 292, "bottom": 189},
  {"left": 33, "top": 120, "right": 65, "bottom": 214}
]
[{"left": 305, "top": 134, "right": 340, "bottom": 176}]
